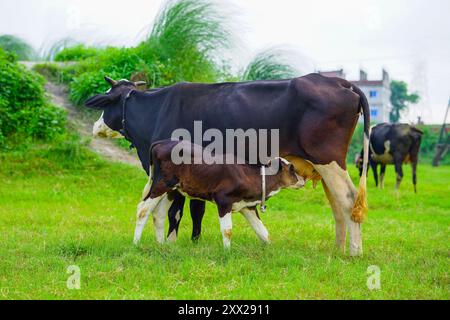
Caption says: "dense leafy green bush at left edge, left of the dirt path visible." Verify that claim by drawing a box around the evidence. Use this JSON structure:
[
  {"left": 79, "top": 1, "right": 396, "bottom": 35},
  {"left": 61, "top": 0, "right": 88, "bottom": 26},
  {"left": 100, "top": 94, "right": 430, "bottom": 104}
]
[{"left": 0, "top": 49, "right": 65, "bottom": 147}]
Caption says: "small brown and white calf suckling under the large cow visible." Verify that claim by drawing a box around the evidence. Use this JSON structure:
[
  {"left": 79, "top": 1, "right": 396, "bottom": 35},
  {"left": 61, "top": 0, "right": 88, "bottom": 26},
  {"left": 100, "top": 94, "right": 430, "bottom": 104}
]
[{"left": 138, "top": 140, "right": 305, "bottom": 247}]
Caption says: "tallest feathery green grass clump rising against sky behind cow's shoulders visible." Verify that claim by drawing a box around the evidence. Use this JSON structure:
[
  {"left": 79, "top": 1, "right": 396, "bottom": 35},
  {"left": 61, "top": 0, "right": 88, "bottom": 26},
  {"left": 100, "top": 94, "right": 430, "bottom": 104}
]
[{"left": 140, "top": 0, "right": 232, "bottom": 81}]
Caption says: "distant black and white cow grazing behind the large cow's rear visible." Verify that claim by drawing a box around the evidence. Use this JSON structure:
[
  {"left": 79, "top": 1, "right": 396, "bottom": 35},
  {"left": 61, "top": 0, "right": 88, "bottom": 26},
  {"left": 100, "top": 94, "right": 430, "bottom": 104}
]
[{"left": 356, "top": 123, "right": 423, "bottom": 192}]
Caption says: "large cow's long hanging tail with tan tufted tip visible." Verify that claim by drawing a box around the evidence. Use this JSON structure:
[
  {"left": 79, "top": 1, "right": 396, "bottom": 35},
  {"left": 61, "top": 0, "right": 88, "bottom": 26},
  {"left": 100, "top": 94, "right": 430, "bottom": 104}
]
[{"left": 351, "top": 86, "right": 370, "bottom": 223}]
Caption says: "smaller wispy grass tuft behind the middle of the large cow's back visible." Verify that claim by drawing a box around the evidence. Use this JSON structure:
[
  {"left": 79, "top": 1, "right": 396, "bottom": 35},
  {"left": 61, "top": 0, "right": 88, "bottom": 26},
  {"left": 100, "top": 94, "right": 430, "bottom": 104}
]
[{"left": 241, "top": 47, "right": 297, "bottom": 81}]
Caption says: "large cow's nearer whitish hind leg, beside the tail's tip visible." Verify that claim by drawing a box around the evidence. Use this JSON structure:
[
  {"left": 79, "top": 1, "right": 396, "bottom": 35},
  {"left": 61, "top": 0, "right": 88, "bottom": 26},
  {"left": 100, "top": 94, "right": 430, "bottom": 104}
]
[{"left": 314, "top": 162, "right": 362, "bottom": 256}]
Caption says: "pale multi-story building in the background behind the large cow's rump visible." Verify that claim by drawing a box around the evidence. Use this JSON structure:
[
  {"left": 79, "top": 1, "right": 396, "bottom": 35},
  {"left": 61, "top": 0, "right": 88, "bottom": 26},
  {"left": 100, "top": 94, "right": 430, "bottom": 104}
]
[{"left": 319, "top": 69, "right": 392, "bottom": 123}]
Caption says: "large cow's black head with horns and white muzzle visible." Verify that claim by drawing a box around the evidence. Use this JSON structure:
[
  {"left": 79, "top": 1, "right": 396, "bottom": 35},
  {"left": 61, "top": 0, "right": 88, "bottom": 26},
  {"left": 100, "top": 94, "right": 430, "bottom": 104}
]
[{"left": 84, "top": 76, "right": 145, "bottom": 138}]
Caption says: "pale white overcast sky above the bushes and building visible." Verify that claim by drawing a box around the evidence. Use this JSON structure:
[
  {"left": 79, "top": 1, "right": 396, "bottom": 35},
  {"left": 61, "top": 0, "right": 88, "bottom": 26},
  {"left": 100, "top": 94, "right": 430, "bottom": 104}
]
[{"left": 0, "top": 0, "right": 450, "bottom": 123}]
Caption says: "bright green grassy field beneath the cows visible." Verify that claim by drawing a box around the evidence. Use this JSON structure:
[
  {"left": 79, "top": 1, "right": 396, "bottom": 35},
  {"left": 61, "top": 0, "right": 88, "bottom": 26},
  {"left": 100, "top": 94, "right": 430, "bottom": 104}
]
[{"left": 0, "top": 146, "right": 450, "bottom": 299}]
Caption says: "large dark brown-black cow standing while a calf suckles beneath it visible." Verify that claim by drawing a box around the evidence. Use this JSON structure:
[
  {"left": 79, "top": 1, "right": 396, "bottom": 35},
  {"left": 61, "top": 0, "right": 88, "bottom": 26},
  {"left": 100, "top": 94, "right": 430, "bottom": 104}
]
[{"left": 85, "top": 74, "right": 370, "bottom": 255}]
